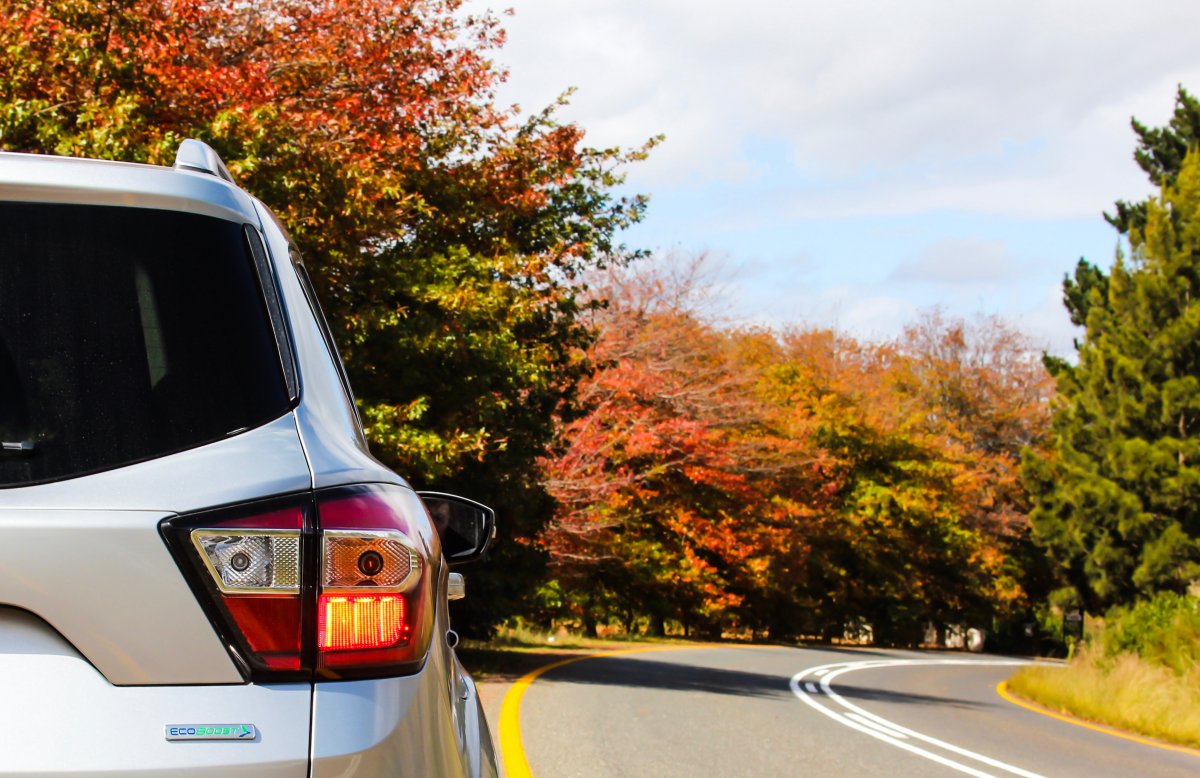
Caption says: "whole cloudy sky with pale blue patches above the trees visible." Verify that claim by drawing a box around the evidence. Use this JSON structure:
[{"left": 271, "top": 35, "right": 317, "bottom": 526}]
[{"left": 484, "top": 0, "right": 1200, "bottom": 354}]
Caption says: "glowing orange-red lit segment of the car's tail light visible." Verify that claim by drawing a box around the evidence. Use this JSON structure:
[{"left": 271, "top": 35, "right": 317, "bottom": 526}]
[{"left": 317, "top": 594, "right": 409, "bottom": 651}]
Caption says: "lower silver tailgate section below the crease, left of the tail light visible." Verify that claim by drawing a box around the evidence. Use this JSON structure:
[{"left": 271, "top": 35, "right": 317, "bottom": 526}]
[{"left": 0, "top": 509, "right": 242, "bottom": 681}]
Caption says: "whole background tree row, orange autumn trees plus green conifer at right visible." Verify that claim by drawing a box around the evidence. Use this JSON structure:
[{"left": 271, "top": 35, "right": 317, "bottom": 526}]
[{"left": 538, "top": 86, "right": 1200, "bottom": 642}]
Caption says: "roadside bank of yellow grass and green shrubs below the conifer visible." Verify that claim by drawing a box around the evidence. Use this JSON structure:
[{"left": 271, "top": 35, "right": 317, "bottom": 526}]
[{"left": 1008, "top": 598, "right": 1200, "bottom": 748}]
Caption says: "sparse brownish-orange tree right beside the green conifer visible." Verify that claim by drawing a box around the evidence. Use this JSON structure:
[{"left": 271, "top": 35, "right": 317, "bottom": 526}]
[{"left": 896, "top": 311, "right": 1054, "bottom": 643}]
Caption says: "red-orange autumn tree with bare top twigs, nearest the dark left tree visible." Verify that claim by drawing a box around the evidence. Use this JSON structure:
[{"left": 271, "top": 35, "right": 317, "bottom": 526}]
[{"left": 541, "top": 258, "right": 816, "bottom": 632}]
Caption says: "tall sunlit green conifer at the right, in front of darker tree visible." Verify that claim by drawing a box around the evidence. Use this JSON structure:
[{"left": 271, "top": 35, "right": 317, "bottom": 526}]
[{"left": 1025, "top": 151, "right": 1200, "bottom": 612}]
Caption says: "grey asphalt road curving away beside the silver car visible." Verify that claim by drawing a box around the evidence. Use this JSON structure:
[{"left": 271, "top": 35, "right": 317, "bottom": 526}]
[{"left": 493, "top": 647, "right": 1200, "bottom": 778}]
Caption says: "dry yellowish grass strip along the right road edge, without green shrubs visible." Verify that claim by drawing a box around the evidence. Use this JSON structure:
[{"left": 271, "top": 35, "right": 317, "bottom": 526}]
[{"left": 1008, "top": 646, "right": 1200, "bottom": 748}]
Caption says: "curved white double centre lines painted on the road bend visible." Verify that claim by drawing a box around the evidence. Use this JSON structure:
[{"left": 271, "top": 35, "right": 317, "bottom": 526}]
[{"left": 790, "top": 659, "right": 1043, "bottom": 778}]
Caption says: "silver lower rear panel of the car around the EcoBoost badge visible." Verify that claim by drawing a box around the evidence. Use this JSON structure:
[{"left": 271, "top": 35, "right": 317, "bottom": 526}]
[{"left": 0, "top": 608, "right": 311, "bottom": 778}]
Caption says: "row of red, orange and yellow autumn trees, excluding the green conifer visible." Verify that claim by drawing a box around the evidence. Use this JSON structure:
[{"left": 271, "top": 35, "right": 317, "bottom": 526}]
[{"left": 538, "top": 263, "right": 1051, "bottom": 642}]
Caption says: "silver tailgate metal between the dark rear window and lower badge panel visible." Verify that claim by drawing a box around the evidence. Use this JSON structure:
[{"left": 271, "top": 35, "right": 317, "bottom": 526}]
[{"left": 0, "top": 413, "right": 312, "bottom": 684}]
